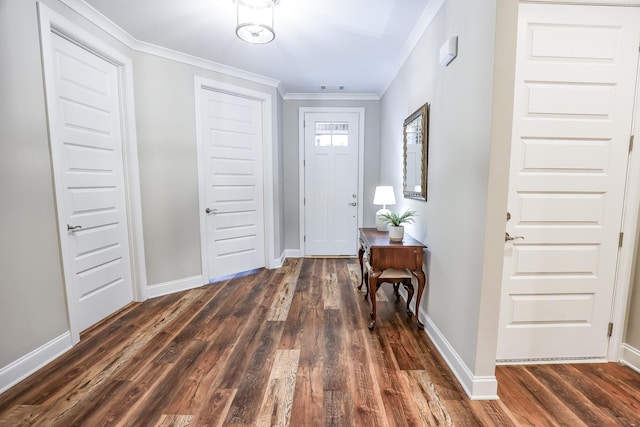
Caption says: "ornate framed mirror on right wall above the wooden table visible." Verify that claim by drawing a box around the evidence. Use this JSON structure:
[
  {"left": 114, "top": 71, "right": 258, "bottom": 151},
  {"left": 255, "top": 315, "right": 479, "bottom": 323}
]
[{"left": 402, "top": 103, "right": 429, "bottom": 200}]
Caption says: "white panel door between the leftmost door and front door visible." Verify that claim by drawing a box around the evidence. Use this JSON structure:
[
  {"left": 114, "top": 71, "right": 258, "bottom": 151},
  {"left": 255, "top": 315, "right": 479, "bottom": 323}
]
[{"left": 201, "top": 88, "right": 265, "bottom": 280}]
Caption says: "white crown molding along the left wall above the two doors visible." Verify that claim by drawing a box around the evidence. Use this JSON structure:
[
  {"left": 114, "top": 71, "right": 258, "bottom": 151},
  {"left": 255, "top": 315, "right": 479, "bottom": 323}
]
[{"left": 60, "top": 0, "right": 280, "bottom": 90}]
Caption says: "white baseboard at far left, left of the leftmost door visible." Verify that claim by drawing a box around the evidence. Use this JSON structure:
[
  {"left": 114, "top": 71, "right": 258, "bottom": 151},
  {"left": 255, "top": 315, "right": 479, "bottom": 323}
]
[{"left": 0, "top": 332, "right": 73, "bottom": 394}]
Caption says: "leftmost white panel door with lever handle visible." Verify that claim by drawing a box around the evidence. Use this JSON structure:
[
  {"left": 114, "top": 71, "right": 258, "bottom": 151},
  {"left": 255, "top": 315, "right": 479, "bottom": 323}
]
[{"left": 48, "top": 35, "right": 133, "bottom": 331}]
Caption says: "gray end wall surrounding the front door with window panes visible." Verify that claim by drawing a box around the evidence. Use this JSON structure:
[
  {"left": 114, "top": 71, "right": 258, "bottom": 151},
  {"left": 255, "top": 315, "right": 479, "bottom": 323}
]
[{"left": 282, "top": 100, "right": 380, "bottom": 249}]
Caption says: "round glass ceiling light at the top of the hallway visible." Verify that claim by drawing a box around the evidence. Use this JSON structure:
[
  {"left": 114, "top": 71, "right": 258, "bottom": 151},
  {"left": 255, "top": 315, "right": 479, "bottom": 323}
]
[{"left": 236, "top": 0, "right": 278, "bottom": 44}]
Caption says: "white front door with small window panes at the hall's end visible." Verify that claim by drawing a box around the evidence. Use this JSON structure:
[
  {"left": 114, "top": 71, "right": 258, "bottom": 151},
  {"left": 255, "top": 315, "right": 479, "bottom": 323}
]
[{"left": 304, "top": 113, "right": 359, "bottom": 256}]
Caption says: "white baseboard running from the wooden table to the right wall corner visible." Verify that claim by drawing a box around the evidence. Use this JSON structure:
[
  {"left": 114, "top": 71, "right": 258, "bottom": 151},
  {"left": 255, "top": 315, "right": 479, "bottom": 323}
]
[{"left": 419, "top": 308, "right": 498, "bottom": 400}]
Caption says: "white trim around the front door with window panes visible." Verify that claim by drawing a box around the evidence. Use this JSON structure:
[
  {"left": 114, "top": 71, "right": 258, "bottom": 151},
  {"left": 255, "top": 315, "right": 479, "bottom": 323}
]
[{"left": 298, "top": 107, "right": 365, "bottom": 257}]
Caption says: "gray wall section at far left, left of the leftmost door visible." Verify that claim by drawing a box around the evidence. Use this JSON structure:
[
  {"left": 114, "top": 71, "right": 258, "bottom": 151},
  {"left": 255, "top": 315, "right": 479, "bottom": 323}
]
[{"left": 0, "top": 0, "right": 68, "bottom": 367}]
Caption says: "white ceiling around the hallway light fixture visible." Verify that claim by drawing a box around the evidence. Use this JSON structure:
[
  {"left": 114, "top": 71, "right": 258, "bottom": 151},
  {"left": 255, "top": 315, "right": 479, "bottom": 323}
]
[{"left": 84, "top": 0, "right": 433, "bottom": 95}]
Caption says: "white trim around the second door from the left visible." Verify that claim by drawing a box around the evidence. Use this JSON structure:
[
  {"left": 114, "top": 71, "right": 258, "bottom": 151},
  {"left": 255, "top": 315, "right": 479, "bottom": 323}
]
[{"left": 194, "top": 76, "right": 280, "bottom": 283}]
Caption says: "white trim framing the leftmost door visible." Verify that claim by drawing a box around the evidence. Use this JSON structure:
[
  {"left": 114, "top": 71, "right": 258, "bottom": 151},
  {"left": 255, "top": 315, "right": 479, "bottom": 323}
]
[{"left": 38, "top": 2, "right": 148, "bottom": 345}]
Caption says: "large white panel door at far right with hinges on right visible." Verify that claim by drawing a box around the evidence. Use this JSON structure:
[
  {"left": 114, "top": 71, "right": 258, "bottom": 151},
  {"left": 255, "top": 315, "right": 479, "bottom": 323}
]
[{"left": 498, "top": 4, "right": 640, "bottom": 360}]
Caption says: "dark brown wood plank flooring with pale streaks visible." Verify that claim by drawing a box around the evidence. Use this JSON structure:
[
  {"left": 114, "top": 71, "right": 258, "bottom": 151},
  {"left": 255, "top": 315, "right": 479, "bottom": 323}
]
[{"left": 0, "top": 259, "right": 640, "bottom": 427}]
